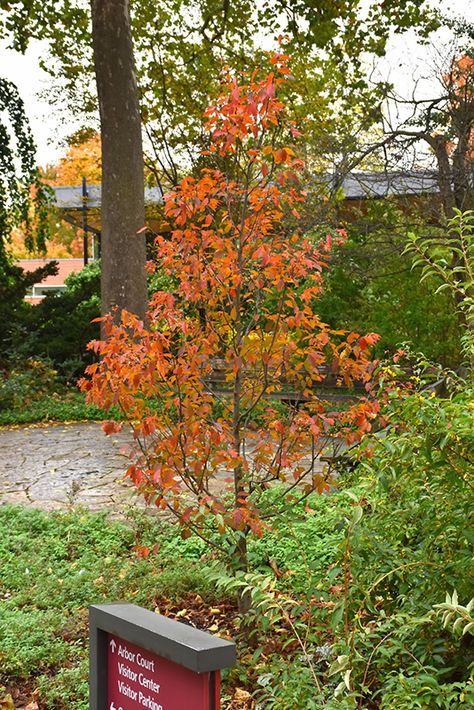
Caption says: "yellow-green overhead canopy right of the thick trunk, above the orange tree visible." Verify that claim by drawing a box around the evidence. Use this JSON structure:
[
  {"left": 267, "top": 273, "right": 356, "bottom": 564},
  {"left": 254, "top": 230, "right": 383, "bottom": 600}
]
[{"left": 132, "top": 0, "right": 436, "bottom": 185}]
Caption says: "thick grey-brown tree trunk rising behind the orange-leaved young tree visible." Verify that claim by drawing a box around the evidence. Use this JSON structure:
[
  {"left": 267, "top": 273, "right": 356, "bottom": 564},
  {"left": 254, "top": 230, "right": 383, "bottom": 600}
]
[{"left": 91, "top": 0, "right": 146, "bottom": 317}]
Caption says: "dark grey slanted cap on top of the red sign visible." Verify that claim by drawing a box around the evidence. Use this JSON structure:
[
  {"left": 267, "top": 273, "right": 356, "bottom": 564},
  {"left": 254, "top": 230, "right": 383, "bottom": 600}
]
[{"left": 89, "top": 603, "right": 235, "bottom": 673}]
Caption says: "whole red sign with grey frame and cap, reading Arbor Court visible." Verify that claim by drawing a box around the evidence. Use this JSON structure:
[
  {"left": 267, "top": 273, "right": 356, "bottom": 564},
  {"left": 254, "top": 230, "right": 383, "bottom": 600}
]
[{"left": 89, "top": 603, "right": 235, "bottom": 710}]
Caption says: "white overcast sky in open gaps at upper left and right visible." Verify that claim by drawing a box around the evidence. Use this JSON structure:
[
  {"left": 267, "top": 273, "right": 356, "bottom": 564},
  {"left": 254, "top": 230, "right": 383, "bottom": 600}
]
[{"left": 0, "top": 0, "right": 474, "bottom": 165}]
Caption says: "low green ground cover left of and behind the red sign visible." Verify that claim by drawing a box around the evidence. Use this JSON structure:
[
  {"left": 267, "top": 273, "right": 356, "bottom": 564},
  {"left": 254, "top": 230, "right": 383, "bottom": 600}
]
[{"left": 0, "top": 506, "right": 213, "bottom": 710}]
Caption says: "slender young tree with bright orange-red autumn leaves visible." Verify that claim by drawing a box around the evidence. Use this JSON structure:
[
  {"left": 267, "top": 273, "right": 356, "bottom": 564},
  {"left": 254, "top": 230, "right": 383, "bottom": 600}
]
[{"left": 82, "top": 55, "right": 378, "bottom": 611}]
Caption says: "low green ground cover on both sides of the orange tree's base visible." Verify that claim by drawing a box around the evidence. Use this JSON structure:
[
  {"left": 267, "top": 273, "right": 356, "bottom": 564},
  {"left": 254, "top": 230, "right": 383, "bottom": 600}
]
[{"left": 0, "top": 494, "right": 349, "bottom": 710}]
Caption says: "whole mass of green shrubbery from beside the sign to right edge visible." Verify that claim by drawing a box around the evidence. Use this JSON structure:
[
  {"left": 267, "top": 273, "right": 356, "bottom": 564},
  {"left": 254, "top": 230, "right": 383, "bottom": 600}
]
[{"left": 198, "top": 376, "right": 474, "bottom": 710}]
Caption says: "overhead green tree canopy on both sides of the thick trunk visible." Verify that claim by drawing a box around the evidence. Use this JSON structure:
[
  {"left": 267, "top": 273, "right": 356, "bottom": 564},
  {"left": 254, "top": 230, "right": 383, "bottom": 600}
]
[{"left": 0, "top": 0, "right": 437, "bottom": 185}]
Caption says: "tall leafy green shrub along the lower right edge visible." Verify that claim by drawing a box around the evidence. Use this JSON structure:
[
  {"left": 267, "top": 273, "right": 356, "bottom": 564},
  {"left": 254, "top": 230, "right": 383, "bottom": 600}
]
[{"left": 326, "top": 392, "right": 474, "bottom": 708}]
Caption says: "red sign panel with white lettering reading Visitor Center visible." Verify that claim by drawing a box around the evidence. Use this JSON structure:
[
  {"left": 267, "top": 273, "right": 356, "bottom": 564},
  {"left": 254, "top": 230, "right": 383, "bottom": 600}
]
[{"left": 107, "top": 634, "right": 219, "bottom": 710}]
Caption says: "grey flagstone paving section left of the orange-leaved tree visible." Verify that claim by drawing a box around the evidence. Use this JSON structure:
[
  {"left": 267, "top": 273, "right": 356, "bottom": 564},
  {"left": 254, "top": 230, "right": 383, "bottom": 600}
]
[{"left": 0, "top": 422, "right": 136, "bottom": 512}]
